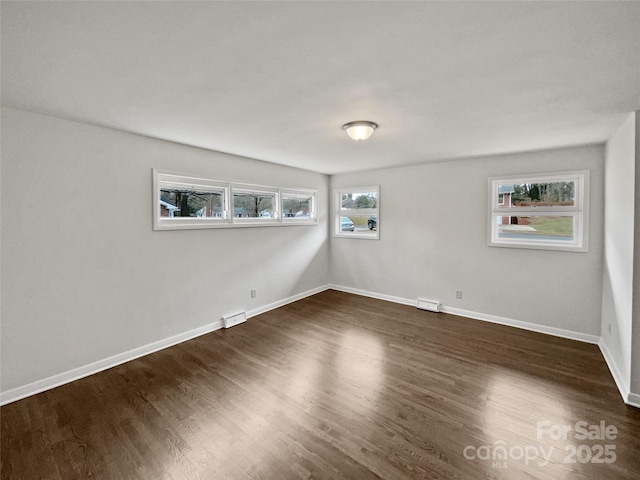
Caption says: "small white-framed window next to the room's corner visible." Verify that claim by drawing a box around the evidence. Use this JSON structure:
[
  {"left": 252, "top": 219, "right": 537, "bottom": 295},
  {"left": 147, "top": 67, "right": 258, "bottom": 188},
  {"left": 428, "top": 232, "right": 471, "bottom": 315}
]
[{"left": 334, "top": 186, "right": 380, "bottom": 240}]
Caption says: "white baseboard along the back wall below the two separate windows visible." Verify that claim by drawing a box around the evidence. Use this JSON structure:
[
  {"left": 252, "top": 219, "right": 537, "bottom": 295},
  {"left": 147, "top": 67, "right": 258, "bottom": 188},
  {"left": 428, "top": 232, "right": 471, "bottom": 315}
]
[{"left": 330, "top": 285, "right": 600, "bottom": 344}]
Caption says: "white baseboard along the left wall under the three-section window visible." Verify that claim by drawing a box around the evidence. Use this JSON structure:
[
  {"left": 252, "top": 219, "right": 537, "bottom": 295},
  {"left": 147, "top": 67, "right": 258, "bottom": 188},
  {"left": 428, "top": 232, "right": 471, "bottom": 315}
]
[{"left": 0, "top": 286, "right": 329, "bottom": 405}]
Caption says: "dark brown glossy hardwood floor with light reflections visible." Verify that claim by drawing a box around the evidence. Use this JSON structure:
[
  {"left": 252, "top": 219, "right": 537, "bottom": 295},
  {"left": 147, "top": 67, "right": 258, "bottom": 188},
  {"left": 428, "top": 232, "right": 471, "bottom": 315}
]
[{"left": 0, "top": 291, "right": 640, "bottom": 480}]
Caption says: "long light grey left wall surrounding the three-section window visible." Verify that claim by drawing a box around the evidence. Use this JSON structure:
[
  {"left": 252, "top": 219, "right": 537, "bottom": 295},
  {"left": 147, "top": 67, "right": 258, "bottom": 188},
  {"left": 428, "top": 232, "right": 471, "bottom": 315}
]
[{"left": 0, "top": 108, "right": 329, "bottom": 392}]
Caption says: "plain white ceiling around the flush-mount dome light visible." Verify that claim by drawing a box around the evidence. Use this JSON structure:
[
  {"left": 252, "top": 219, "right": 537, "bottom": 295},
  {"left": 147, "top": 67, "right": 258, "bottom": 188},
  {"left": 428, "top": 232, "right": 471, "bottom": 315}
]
[{"left": 1, "top": 1, "right": 640, "bottom": 174}]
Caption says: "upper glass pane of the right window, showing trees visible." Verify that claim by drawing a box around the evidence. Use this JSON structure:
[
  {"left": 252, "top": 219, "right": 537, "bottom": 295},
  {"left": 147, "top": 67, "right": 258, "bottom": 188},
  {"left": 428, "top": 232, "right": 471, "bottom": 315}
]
[{"left": 496, "top": 180, "right": 576, "bottom": 208}]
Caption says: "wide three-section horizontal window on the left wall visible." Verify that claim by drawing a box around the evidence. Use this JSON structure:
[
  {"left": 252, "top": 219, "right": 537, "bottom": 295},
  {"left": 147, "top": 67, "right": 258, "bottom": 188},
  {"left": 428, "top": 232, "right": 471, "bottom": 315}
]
[{"left": 153, "top": 169, "right": 318, "bottom": 230}]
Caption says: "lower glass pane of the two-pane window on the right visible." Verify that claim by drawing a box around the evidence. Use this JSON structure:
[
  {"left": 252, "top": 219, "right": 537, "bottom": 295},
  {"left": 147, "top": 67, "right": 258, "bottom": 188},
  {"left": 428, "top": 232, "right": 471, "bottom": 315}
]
[{"left": 496, "top": 215, "right": 575, "bottom": 242}]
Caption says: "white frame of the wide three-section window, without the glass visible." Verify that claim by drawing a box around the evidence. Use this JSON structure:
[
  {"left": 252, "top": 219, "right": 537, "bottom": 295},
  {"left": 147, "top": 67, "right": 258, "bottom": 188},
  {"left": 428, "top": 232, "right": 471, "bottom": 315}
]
[{"left": 152, "top": 168, "right": 318, "bottom": 230}]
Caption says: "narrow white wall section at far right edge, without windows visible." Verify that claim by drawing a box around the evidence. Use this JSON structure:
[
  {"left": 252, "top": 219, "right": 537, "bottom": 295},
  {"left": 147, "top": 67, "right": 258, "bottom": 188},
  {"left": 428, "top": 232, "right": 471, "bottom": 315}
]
[{"left": 600, "top": 114, "right": 636, "bottom": 395}]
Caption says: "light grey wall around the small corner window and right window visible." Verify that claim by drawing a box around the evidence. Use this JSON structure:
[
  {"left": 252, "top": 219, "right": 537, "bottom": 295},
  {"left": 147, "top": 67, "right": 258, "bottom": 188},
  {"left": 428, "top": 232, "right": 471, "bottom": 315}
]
[{"left": 331, "top": 146, "right": 604, "bottom": 338}]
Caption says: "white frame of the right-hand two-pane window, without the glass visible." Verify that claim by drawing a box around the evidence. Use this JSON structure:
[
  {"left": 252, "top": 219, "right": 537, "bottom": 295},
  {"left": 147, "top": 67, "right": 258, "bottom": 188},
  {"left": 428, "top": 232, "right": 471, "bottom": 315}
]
[{"left": 487, "top": 170, "right": 590, "bottom": 252}]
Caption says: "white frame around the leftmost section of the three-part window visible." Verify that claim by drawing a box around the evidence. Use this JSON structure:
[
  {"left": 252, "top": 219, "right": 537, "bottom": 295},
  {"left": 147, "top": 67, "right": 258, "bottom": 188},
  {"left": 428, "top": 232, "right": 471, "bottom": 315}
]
[{"left": 153, "top": 169, "right": 231, "bottom": 230}]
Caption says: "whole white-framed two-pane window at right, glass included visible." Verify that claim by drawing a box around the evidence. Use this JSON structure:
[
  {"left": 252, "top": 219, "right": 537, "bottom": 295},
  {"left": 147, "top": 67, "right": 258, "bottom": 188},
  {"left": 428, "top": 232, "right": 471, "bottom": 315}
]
[{"left": 489, "top": 171, "right": 589, "bottom": 252}]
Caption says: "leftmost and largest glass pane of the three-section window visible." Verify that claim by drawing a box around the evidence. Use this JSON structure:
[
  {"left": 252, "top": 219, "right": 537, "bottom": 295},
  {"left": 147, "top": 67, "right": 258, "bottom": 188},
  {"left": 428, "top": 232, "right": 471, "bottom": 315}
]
[{"left": 160, "top": 187, "right": 224, "bottom": 218}]
